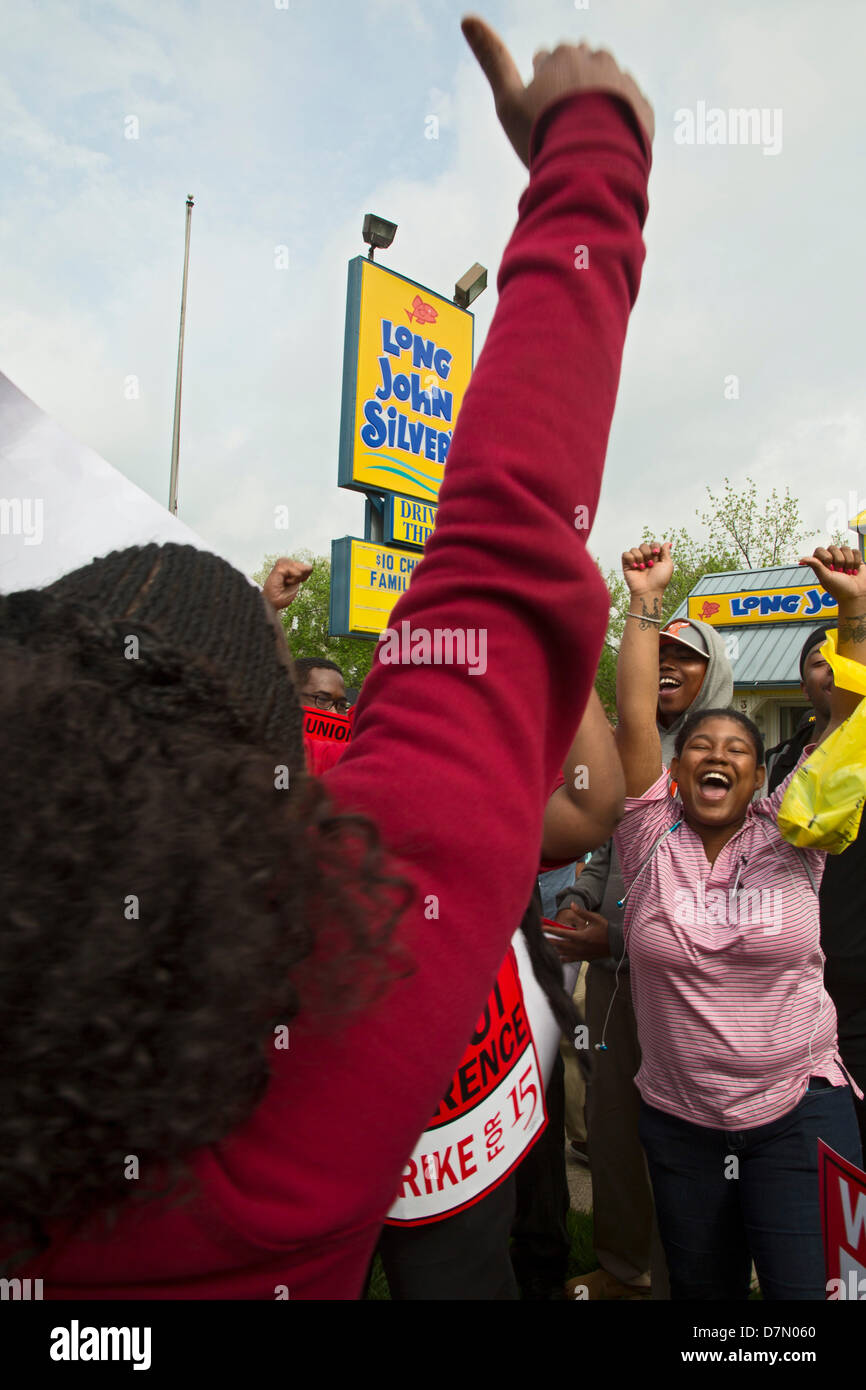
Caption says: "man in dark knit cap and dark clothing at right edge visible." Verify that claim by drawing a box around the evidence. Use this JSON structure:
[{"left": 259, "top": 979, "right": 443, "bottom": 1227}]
[{"left": 767, "top": 623, "right": 866, "bottom": 1150}]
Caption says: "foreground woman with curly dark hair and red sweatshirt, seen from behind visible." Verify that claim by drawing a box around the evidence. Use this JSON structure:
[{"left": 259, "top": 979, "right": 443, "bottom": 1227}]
[{"left": 0, "top": 21, "right": 652, "bottom": 1298}]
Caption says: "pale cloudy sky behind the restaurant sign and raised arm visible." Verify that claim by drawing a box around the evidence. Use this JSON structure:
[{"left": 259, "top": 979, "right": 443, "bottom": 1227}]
[{"left": 0, "top": 0, "right": 866, "bottom": 571}]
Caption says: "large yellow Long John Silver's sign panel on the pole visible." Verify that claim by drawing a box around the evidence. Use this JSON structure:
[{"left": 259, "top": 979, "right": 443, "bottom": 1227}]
[{"left": 338, "top": 256, "right": 474, "bottom": 502}]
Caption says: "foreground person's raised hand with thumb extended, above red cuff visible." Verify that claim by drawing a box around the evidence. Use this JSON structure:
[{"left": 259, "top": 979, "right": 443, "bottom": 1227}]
[{"left": 461, "top": 15, "right": 655, "bottom": 168}]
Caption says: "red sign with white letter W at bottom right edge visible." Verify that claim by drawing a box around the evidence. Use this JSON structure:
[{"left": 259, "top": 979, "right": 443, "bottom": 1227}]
[{"left": 817, "top": 1138, "right": 866, "bottom": 1302}]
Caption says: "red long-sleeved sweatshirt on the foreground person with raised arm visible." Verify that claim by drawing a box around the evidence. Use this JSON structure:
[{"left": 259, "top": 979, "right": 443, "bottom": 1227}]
[{"left": 39, "top": 93, "right": 649, "bottom": 1300}]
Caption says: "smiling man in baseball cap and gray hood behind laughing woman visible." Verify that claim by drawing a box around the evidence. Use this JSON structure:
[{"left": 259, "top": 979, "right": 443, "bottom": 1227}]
[{"left": 547, "top": 546, "right": 734, "bottom": 1298}]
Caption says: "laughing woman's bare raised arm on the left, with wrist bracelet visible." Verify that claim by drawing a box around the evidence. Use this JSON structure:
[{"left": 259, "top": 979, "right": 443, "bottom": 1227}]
[{"left": 616, "top": 541, "right": 674, "bottom": 796}]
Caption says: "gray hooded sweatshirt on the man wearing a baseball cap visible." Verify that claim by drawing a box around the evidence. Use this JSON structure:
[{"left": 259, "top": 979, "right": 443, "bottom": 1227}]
[{"left": 556, "top": 619, "right": 734, "bottom": 970}]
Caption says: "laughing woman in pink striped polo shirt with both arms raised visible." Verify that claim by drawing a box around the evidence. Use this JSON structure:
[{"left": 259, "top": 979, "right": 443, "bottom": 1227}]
[{"left": 616, "top": 545, "right": 866, "bottom": 1300}]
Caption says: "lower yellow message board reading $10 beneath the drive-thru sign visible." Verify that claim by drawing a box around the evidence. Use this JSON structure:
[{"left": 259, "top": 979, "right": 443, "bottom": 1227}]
[{"left": 329, "top": 535, "right": 421, "bottom": 637}]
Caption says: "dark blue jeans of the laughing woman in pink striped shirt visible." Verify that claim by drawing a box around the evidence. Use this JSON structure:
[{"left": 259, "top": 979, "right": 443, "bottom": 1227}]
[{"left": 639, "top": 1077, "right": 862, "bottom": 1300}]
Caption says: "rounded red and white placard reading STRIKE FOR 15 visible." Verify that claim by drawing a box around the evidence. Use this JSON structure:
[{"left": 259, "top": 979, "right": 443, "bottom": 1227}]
[{"left": 388, "top": 947, "right": 548, "bottom": 1226}]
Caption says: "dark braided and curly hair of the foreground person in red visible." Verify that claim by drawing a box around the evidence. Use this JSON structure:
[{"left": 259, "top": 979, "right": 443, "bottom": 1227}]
[{"left": 0, "top": 546, "right": 411, "bottom": 1268}]
